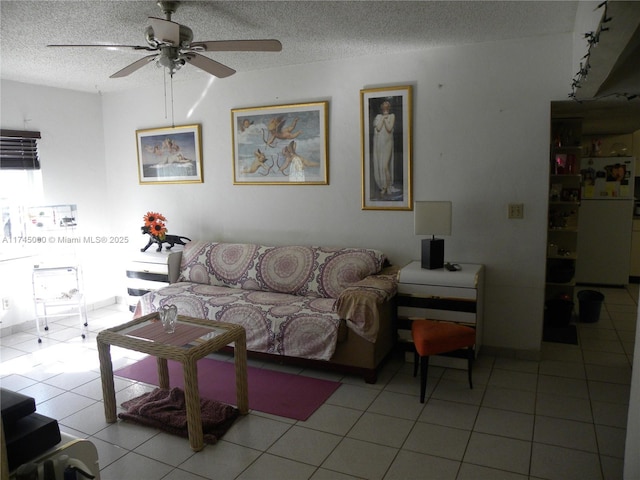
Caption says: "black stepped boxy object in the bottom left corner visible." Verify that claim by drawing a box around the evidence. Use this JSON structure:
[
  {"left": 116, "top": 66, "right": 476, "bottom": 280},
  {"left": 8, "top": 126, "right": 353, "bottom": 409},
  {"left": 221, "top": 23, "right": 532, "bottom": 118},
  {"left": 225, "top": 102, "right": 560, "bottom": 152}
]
[{"left": 0, "top": 388, "right": 62, "bottom": 470}]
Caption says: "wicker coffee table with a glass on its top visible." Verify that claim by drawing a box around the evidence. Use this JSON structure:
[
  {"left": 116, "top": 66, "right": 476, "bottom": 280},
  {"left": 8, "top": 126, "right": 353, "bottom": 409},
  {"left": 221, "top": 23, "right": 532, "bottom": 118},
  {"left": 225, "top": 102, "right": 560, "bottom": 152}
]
[{"left": 97, "top": 313, "right": 249, "bottom": 452}]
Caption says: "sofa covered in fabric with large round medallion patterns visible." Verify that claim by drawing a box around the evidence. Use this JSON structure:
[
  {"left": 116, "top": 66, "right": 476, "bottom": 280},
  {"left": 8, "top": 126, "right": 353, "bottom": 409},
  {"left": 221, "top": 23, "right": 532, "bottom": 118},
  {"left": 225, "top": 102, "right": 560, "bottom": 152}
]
[{"left": 134, "top": 241, "right": 398, "bottom": 383}]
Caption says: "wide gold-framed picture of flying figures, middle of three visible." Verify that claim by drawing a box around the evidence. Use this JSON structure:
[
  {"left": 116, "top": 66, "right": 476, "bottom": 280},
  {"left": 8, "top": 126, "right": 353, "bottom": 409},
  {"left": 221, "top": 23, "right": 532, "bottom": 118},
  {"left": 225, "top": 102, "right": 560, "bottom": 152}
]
[{"left": 231, "top": 101, "right": 329, "bottom": 185}]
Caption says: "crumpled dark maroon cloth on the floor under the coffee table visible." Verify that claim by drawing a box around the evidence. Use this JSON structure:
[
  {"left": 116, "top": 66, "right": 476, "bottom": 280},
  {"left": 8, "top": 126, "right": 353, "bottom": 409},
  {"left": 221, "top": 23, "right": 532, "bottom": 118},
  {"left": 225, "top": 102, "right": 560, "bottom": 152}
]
[{"left": 118, "top": 387, "right": 239, "bottom": 444}]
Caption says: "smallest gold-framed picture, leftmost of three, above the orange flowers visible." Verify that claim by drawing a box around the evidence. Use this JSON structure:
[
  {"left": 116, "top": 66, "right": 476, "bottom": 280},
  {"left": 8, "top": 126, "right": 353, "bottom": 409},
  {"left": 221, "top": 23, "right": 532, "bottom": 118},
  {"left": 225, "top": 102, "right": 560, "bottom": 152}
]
[{"left": 136, "top": 125, "right": 203, "bottom": 185}]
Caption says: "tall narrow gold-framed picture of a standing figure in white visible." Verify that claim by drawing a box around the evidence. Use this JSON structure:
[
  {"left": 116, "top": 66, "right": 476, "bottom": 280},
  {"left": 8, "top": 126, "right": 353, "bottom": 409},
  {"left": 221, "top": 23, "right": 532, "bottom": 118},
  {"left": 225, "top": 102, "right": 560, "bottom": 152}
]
[{"left": 360, "top": 85, "right": 413, "bottom": 210}]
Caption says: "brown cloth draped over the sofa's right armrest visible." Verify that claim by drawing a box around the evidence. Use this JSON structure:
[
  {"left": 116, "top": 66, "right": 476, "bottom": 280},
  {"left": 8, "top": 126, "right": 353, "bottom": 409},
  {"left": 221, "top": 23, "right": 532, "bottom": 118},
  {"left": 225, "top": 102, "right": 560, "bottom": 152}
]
[{"left": 336, "top": 267, "right": 399, "bottom": 342}]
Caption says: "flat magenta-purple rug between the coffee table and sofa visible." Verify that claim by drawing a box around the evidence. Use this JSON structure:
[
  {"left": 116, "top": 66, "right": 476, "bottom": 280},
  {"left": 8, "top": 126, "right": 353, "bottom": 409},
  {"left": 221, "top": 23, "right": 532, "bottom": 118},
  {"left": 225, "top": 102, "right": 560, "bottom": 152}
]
[{"left": 113, "top": 356, "right": 340, "bottom": 420}]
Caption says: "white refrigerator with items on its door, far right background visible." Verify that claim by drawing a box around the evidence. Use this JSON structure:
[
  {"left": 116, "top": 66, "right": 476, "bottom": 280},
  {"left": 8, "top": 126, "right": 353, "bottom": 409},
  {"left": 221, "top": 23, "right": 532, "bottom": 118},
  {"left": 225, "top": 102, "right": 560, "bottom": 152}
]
[{"left": 576, "top": 157, "right": 635, "bottom": 286}]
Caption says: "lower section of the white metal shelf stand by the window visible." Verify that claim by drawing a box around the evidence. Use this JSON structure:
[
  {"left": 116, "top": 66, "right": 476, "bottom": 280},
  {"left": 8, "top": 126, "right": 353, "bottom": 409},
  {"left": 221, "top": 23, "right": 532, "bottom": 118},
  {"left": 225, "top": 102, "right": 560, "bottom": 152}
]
[{"left": 32, "top": 265, "right": 88, "bottom": 343}]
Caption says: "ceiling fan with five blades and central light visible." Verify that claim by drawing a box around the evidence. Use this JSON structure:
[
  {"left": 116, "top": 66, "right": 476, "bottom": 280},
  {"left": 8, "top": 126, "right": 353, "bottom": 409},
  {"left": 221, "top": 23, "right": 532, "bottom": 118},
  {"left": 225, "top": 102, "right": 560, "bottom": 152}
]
[{"left": 47, "top": 0, "right": 282, "bottom": 78}]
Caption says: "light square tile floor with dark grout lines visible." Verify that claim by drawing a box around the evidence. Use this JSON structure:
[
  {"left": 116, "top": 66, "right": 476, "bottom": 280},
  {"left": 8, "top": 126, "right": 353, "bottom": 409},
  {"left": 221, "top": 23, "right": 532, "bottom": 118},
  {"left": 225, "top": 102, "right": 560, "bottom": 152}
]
[{"left": 0, "top": 285, "right": 638, "bottom": 480}]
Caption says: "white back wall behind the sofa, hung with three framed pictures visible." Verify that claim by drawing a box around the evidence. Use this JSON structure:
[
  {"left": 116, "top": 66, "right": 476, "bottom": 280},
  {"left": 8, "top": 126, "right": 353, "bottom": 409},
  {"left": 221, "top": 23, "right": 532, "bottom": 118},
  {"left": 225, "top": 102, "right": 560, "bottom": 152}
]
[{"left": 103, "top": 34, "right": 572, "bottom": 351}]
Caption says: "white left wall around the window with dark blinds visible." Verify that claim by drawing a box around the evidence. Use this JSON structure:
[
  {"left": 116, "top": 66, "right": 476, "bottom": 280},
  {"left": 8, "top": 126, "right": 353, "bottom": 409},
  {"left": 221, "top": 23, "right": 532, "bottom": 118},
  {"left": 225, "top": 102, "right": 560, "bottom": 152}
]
[{"left": 0, "top": 80, "right": 114, "bottom": 327}]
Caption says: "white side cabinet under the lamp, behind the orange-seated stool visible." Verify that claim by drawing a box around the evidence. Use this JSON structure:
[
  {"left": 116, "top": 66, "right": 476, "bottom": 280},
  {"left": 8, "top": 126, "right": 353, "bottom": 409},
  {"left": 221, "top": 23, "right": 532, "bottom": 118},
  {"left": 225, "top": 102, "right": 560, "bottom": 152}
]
[{"left": 397, "top": 261, "right": 484, "bottom": 369}]
